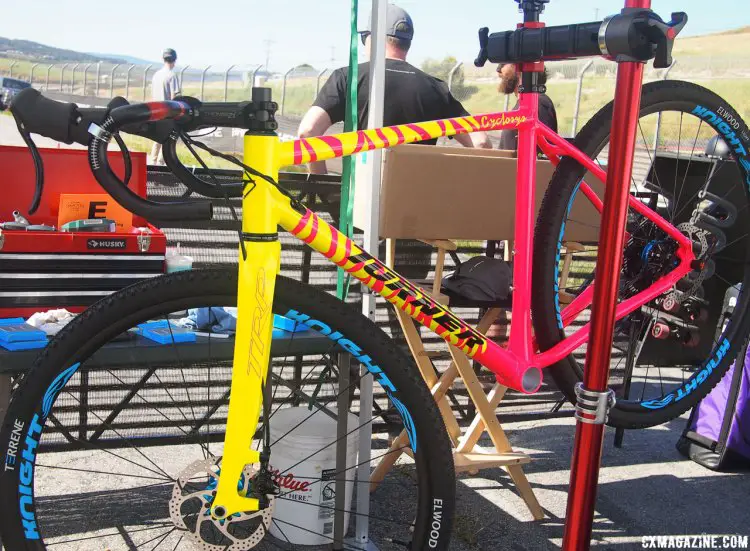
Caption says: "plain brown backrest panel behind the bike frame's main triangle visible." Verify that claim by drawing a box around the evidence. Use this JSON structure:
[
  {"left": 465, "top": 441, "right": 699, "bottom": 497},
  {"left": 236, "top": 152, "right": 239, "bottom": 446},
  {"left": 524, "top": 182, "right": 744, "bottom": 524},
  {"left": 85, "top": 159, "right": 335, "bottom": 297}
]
[{"left": 370, "top": 145, "right": 604, "bottom": 242}]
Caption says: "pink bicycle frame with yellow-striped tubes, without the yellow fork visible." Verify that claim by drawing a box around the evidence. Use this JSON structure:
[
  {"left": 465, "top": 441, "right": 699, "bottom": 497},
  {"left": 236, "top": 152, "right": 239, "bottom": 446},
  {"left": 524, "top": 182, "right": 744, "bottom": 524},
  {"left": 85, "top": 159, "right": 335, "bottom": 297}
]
[{"left": 281, "top": 88, "right": 695, "bottom": 393}]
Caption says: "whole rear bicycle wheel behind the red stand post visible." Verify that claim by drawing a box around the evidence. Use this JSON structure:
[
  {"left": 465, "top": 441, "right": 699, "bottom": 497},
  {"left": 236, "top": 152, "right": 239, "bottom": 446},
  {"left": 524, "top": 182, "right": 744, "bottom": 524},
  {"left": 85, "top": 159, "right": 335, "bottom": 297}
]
[{"left": 532, "top": 81, "right": 750, "bottom": 428}]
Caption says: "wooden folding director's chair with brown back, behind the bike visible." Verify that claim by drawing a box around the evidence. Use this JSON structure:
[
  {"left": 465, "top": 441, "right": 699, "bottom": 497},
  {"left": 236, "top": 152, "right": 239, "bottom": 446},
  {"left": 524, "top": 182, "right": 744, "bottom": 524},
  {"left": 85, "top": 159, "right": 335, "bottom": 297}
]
[{"left": 362, "top": 145, "right": 604, "bottom": 520}]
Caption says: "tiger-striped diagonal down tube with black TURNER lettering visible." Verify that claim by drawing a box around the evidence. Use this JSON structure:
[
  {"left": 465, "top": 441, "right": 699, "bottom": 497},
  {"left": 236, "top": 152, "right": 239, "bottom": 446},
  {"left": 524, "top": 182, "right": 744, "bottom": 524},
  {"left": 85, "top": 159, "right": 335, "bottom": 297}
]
[{"left": 286, "top": 209, "right": 488, "bottom": 358}]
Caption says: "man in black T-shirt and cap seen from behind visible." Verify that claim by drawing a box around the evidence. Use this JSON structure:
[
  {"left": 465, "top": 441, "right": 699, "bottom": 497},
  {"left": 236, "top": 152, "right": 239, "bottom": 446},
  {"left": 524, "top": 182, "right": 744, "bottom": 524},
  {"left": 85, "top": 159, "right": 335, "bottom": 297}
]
[{"left": 298, "top": 4, "right": 491, "bottom": 174}]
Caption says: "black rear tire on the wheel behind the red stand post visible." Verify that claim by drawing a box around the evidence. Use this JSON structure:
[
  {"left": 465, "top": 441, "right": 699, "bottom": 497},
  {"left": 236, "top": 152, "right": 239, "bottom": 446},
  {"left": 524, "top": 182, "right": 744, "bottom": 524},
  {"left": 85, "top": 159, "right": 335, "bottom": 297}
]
[{"left": 532, "top": 81, "right": 750, "bottom": 428}]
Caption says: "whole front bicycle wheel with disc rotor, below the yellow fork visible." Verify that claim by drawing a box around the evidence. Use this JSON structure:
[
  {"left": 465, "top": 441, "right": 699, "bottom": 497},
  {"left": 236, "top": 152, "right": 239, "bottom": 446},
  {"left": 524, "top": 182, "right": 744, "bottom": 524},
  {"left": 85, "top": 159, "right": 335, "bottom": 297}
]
[{"left": 0, "top": 270, "right": 455, "bottom": 551}]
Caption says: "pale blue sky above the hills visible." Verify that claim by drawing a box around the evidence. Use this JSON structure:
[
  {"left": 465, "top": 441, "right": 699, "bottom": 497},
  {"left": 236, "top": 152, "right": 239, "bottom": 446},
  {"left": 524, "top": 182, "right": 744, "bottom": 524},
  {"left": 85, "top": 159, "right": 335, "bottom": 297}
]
[{"left": 0, "top": 0, "right": 750, "bottom": 70}]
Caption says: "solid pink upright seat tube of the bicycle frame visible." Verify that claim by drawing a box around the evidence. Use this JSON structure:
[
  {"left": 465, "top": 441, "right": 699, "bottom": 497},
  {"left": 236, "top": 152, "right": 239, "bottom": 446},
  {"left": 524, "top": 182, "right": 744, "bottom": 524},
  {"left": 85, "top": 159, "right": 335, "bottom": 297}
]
[{"left": 508, "top": 73, "right": 539, "bottom": 365}]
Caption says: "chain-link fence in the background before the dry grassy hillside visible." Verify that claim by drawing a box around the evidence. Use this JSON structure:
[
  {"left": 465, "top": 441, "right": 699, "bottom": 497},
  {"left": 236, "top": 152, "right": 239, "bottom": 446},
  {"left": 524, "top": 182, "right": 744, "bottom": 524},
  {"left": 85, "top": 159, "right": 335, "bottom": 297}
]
[{"left": 0, "top": 55, "right": 750, "bottom": 149}]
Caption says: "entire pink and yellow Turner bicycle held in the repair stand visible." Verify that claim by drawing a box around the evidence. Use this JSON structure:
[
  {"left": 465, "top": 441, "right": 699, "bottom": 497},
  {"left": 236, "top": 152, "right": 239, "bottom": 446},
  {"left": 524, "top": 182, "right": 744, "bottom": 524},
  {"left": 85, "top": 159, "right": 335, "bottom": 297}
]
[{"left": 0, "top": 0, "right": 750, "bottom": 550}]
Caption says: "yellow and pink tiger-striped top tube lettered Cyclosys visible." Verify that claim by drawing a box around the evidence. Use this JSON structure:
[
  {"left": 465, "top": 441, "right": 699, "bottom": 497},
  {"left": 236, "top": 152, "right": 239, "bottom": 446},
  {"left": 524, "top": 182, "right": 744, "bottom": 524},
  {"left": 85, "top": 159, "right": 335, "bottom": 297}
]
[{"left": 280, "top": 111, "right": 532, "bottom": 166}]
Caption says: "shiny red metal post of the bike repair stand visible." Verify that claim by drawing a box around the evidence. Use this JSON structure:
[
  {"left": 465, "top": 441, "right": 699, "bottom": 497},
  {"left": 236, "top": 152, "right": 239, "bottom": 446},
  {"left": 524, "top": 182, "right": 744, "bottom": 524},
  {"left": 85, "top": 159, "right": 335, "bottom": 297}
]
[{"left": 563, "top": 0, "right": 651, "bottom": 551}]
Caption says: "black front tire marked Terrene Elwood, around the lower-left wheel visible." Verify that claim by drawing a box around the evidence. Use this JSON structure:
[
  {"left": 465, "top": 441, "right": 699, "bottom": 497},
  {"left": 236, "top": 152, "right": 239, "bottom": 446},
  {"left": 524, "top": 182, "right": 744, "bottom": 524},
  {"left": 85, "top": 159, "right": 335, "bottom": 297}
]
[{"left": 0, "top": 269, "right": 455, "bottom": 551}]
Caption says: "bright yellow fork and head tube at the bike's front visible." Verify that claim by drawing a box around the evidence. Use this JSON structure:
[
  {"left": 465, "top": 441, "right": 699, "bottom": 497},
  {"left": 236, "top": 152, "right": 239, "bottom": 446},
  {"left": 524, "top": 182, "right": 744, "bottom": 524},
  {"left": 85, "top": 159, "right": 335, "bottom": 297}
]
[{"left": 212, "top": 132, "right": 281, "bottom": 518}]
